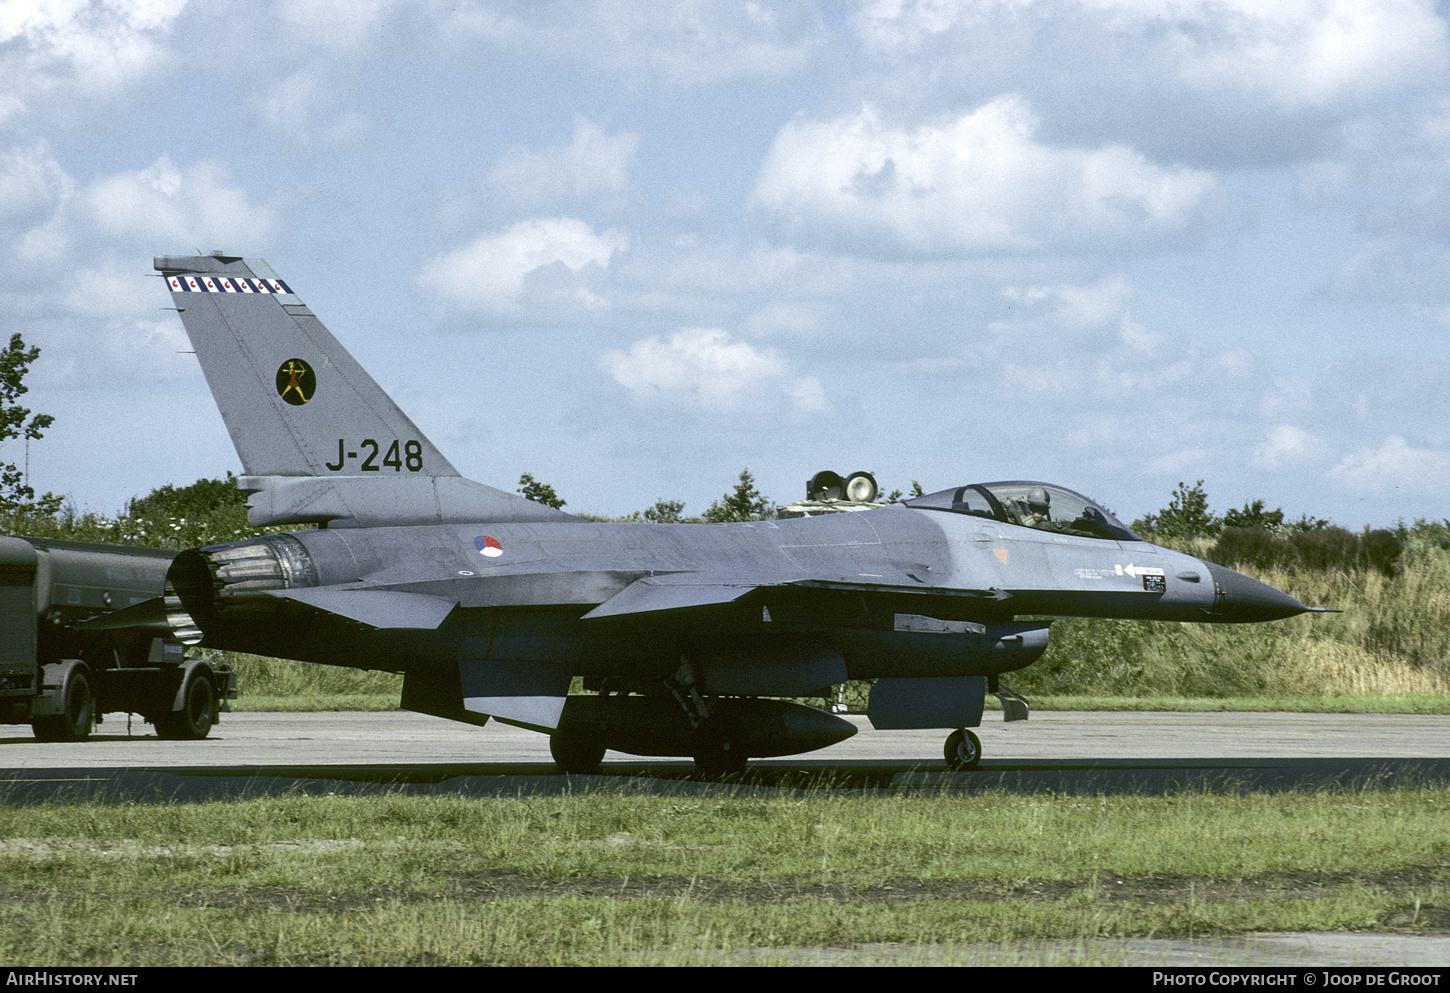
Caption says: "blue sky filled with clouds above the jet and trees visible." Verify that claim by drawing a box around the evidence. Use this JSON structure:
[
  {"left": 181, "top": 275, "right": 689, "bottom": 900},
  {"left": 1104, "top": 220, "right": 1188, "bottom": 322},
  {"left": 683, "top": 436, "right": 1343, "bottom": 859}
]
[{"left": 0, "top": 0, "right": 1450, "bottom": 528}]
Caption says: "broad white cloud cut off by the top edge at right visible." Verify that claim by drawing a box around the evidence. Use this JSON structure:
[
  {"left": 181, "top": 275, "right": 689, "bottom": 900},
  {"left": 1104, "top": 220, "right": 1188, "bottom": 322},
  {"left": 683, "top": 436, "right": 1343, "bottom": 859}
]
[{"left": 851, "top": 0, "right": 1447, "bottom": 110}]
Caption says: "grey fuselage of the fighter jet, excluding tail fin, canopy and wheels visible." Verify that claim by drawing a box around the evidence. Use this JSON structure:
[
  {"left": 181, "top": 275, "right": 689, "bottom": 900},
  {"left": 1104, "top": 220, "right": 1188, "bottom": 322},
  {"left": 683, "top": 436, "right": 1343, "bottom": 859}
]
[{"left": 166, "top": 506, "right": 1293, "bottom": 678}]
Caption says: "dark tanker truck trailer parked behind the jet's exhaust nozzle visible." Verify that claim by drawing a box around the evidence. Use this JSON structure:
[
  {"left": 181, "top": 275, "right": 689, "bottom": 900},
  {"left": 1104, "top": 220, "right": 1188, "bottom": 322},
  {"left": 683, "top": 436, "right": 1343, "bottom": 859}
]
[{"left": 0, "top": 535, "right": 236, "bottom": 741}]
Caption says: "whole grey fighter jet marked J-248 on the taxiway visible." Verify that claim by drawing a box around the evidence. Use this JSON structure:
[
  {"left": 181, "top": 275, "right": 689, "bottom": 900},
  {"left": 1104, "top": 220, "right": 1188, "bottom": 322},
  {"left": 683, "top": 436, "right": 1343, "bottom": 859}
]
[{"left": 155, "top": 254, "right": 1309, "bottom": 773}]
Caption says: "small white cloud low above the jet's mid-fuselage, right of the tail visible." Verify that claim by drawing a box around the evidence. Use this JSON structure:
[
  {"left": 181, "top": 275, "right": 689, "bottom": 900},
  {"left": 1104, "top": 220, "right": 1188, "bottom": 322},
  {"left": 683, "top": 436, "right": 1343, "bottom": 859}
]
[{"left": 599, "top": 328, "right": 828, "bottom": 413}]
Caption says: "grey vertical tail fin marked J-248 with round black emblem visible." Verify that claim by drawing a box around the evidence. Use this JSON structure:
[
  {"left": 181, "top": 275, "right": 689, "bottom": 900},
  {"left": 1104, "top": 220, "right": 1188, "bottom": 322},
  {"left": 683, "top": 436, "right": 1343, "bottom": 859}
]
[{"left": 155, "top": 255, "right": 571, "bottom": 526}]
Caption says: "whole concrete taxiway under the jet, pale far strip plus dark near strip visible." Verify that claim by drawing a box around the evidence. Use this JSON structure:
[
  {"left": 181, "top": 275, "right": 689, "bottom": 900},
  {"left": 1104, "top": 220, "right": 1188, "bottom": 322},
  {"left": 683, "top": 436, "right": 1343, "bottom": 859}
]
[{"left": 0, "top": 710, "right": 1450, "bottom": 800}]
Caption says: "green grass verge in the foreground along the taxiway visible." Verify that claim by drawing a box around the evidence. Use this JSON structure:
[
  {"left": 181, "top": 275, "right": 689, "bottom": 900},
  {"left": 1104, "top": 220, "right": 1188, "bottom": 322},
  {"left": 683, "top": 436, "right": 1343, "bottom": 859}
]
[{"left": 0, "top": 789, "right": 1450, "bottom": 965}]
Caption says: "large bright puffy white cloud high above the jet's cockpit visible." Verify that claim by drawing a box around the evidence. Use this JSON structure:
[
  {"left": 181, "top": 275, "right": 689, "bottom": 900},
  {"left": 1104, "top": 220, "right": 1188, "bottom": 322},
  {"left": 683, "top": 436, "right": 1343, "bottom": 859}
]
[{"left": 751, "top": 96, "right": 1217, "bottom": 254}]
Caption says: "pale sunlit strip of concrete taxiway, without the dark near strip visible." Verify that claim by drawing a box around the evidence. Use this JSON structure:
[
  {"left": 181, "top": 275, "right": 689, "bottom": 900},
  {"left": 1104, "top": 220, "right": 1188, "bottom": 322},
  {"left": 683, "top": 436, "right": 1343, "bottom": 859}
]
[{"left": 8, "top": 710, "right": 1450, "bottom": 768}]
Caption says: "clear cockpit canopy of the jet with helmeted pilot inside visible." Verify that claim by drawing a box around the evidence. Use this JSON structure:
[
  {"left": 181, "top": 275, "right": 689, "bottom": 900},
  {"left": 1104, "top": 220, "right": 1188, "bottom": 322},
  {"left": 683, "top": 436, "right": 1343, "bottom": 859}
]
[{"left": 906, "top": 480, "right": 1143, "bottom": 541}]
